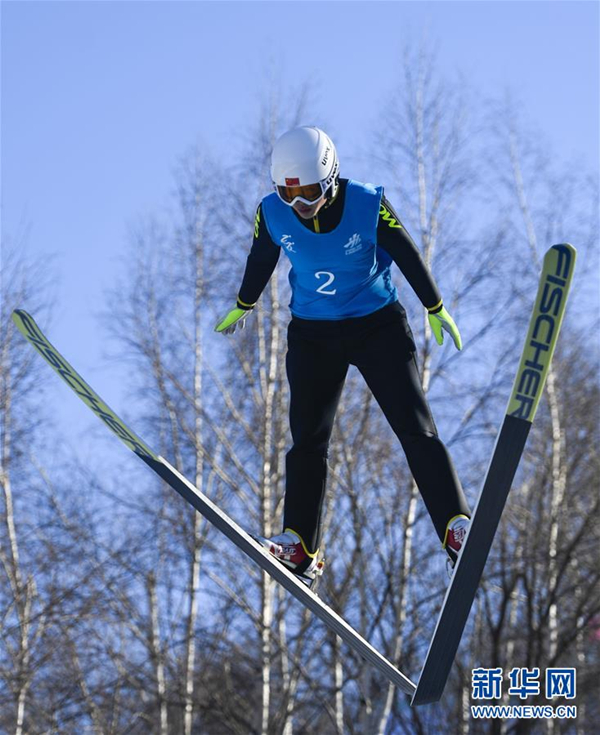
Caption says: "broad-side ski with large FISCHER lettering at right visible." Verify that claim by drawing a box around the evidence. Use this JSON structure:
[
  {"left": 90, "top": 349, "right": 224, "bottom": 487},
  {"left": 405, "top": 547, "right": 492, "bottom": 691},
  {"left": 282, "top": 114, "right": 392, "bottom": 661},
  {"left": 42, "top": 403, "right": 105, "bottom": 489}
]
[{"left": 412, "top": 244, "right": 576, "bottom": 705}]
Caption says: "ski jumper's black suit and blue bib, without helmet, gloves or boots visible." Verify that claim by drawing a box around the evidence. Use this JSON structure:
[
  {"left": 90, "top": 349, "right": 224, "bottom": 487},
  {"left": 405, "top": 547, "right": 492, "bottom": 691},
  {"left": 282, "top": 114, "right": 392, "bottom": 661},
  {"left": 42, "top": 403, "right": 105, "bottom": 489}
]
[{"left": 238, "top": 179, "right": 470, "bottom": 552}]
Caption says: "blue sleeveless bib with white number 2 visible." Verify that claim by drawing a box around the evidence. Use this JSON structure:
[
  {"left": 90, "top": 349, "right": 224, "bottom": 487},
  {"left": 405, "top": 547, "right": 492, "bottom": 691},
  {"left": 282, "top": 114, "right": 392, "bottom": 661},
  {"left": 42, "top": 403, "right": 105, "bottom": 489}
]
[{"left": 262, "top": 181, "right": 398, "bottom": 319}]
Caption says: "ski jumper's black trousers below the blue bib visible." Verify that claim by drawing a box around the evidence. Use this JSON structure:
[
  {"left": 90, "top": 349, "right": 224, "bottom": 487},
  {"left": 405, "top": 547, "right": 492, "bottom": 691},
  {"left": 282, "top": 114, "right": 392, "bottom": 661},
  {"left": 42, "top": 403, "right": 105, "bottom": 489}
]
[{"left": 284, "top": 302, "right": 471, "bottom": 551}]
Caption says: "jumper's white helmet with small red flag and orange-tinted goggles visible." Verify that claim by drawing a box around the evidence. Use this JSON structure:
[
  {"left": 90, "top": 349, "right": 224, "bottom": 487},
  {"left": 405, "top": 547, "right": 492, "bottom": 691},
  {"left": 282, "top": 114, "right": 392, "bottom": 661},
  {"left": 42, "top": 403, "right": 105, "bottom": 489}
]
[{"left": 271, "top": 126, "right": 340, "bottom": 207}]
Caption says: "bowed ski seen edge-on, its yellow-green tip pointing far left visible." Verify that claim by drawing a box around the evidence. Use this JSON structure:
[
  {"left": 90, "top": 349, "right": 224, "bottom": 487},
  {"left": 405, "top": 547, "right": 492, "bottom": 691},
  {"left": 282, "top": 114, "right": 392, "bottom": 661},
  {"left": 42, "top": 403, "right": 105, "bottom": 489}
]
[{"left": 12, "top": 309, "right": 415, "bottom": 694}]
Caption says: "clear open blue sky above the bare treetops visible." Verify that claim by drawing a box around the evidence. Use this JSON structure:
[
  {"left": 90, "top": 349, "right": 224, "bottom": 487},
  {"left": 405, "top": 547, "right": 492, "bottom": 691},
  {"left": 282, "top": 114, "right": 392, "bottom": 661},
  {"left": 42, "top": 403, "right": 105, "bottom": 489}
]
[{"left": 1, "top": 0, "right": 600, "bottom": 460}]
